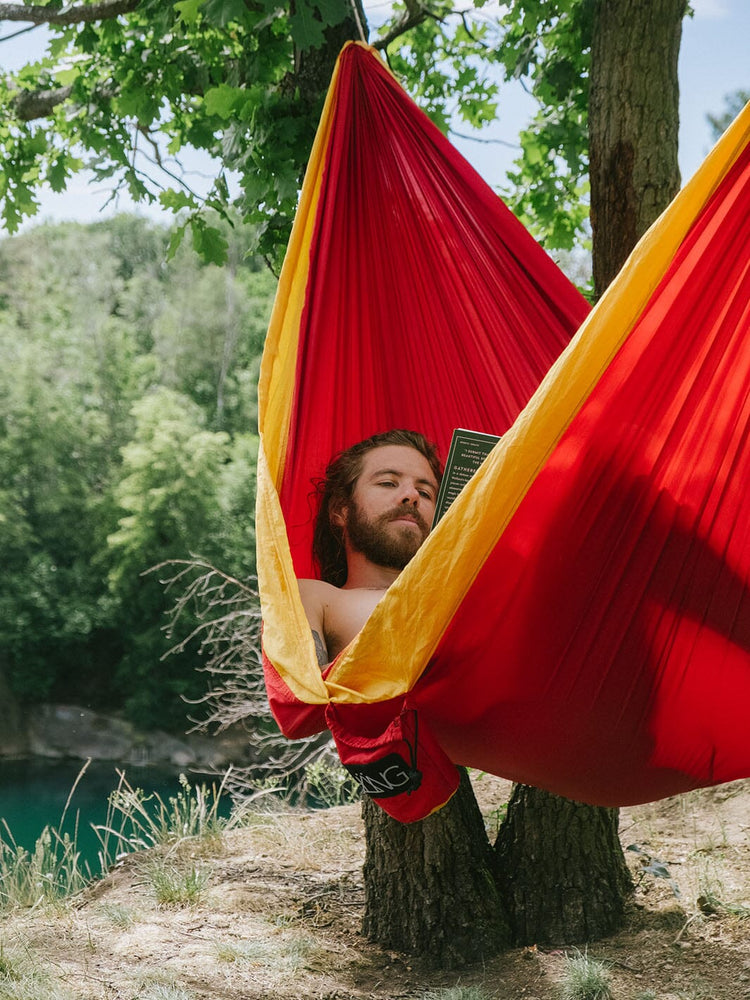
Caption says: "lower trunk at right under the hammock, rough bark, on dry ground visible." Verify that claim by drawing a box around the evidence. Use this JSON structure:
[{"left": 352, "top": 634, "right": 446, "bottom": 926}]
[{"left": 495, "top": 785, "right": 632, "bottom": 945}]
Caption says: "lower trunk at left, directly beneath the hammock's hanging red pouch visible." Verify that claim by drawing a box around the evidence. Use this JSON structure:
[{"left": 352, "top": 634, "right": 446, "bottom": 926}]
[{"left": 362, "top": 771, "right": 510, "bottom": 969}]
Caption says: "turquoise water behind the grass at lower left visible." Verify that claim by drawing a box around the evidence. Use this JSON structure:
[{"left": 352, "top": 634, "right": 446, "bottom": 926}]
[{"left": 0, "top": 759, "right": 230, "bottom": 874}]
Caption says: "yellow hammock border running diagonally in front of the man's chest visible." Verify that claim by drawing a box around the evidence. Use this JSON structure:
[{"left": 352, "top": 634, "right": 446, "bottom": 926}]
[{"left": 326, "top": 95, "right": 750, "bottom": 702}]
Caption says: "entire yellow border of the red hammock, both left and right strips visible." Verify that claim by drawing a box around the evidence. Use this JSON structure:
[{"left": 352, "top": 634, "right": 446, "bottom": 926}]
[{"left": 257, "top": 54, "right": 750, "bottom": 704}]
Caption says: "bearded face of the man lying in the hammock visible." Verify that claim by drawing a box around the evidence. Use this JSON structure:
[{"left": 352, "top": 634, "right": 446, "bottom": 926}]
[{"left": 343, "top": 445, "right": 438, "bottom": 570}]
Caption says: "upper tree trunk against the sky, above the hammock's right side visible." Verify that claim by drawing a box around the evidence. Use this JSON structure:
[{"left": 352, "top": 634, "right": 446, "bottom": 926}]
[{"left": 589, "top": 0, "right": 686, "bottom": 295}]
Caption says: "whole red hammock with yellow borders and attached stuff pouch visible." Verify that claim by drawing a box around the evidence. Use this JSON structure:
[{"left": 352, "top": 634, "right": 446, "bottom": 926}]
[{"left": 256, "top": 43, "right": 750, "bottom": 821}]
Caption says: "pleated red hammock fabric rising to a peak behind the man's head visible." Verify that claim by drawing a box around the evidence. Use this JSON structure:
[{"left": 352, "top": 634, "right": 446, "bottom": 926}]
[{"left": 280, "top": 45, "right": 589, "bottom": 577}]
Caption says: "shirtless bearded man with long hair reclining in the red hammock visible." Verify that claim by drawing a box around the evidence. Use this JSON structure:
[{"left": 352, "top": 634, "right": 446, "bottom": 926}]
[{"left": 299, "top": 430, "right": 442, "bottom": 666}]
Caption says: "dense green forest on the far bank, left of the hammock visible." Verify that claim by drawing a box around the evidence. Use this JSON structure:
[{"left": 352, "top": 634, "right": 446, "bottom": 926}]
[{"left": 0, "top": 217, "right": 274, "bottom": 728}]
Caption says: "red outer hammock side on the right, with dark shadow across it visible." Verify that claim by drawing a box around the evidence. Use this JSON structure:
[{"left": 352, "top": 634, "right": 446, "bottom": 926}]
[{"left": 418, "top": 139, "right": 750, "bottom": 805}]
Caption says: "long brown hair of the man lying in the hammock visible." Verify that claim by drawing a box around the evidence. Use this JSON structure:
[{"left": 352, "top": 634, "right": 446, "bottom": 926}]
[{"left": 313, "top": 430, "right": 443, "bottom": 587}]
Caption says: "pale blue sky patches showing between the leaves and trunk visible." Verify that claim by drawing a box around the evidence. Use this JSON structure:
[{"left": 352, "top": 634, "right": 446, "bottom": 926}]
[{"left": 0, "top": 0, "right": 750, "bottom": 232}]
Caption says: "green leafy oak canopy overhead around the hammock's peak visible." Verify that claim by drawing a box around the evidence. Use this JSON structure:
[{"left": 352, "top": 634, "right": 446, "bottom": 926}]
[{"left": 0, "top": 0, "right": 604, "bottom": 262}]
